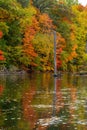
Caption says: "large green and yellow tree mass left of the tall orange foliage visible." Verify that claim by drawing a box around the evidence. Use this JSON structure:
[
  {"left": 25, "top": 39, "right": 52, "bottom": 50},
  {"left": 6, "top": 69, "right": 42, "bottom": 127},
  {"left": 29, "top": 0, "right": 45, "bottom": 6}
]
[{"left": 0, "top": 0, "right": 35, "bottom": 70}]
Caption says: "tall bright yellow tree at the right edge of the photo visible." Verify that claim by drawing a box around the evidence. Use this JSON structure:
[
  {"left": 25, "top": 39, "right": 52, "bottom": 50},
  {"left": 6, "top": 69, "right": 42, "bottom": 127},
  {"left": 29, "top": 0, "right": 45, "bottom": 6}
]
[{"left": 72, "top": 5, "right": 87, "bottom": 68}]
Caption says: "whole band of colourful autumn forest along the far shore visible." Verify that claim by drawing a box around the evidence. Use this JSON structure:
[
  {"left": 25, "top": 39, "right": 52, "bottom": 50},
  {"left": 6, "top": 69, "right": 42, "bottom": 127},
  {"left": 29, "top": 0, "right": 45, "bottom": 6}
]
[{"left": 0, "top": 0, "right": 87, "bottom": 72}]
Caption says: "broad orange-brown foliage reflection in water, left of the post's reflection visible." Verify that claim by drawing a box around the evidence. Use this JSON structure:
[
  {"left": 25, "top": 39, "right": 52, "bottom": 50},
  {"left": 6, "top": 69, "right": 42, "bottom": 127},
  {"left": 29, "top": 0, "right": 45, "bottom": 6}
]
[{"left": 22, "top": 87, "right": 37, "bottom": 128}]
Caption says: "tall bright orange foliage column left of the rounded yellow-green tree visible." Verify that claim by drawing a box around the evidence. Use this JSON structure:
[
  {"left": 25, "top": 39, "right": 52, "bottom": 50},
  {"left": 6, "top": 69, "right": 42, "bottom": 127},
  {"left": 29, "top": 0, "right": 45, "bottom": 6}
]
[{"left": 23, "top": 17, "right": 39, "bottom": 66}]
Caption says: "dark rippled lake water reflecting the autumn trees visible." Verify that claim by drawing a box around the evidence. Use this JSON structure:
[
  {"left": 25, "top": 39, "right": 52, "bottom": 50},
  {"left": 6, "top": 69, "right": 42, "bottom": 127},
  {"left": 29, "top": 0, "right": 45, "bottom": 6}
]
[{"left": 0, "top": 73, "right": 87, "bottom": 130}]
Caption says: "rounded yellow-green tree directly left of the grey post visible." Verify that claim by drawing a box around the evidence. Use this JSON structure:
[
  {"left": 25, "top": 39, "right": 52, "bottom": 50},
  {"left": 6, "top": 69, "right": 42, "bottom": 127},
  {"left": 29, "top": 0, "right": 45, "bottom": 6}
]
[{"left": 33, "top": 33, "right": 53, "bottom": 71}]
